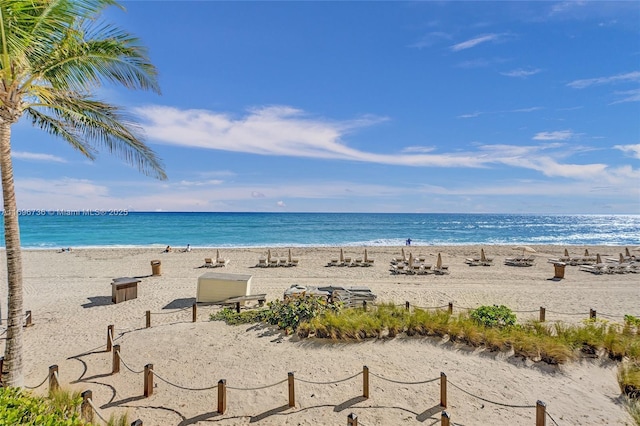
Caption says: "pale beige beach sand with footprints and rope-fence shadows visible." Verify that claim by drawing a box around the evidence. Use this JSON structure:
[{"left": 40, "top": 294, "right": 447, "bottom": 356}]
[{"left": 0, "top": 246, "right": 640, "bottom": 426}]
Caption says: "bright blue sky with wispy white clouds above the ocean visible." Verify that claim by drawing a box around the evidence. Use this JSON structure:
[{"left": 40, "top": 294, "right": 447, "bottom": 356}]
[{"left": 12, "top": 1, "right": 640, "bottom": 214}]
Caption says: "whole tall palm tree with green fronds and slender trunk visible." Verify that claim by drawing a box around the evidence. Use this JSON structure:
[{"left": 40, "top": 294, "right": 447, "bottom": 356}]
[{"left": 0, "top": 0, "right": 166, "bottom": 387}]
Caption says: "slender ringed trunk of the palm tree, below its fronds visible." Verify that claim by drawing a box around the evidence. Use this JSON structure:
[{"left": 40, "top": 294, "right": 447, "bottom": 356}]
[{"left": 0, "top": 120, "right": 24, "bottom": 387}]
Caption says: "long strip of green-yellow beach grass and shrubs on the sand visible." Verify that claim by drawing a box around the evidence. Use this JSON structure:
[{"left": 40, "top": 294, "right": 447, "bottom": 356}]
[{"left": 211, "top": 295, "right": 640, "bottom": 365}]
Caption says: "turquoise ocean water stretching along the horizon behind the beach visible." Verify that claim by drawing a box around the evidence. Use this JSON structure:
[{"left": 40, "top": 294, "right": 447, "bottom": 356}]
[{"left": 0, "top": 211, "right": 640, "bottom": 249}]
